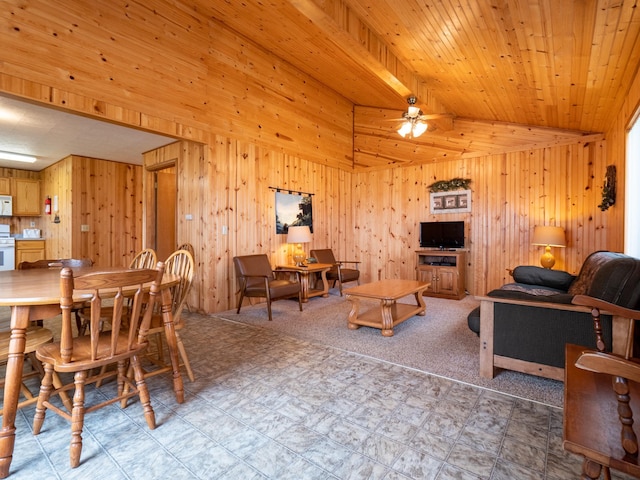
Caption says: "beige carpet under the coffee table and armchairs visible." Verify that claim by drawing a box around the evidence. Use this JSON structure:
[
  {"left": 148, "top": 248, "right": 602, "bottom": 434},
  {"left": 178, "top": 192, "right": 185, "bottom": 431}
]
[{"left": 216, "top": 289, "right": 563, "bottom": 407}]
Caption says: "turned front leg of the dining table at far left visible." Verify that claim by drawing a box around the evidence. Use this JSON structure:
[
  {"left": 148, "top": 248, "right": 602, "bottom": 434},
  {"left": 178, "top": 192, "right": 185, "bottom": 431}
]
[{"left": 0, "top": 306, "right": 30, "bottom": 478}]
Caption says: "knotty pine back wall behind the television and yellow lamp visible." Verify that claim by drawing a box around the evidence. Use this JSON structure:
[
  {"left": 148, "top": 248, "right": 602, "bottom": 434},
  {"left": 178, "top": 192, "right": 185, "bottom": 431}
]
[{"left": 354, "top": 142, "right": 623, "bottom": 295}]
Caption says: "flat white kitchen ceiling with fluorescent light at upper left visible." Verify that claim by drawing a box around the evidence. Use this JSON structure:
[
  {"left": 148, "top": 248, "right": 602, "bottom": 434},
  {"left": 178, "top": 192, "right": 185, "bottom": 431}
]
[{"left": 0, "top": 95, "right": 176, "bottom": 171}]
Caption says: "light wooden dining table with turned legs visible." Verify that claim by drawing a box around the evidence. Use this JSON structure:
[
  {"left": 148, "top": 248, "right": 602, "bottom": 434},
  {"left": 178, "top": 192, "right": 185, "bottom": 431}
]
[{"left": 0, "top": 267, "right": 184, "bottom": 478}]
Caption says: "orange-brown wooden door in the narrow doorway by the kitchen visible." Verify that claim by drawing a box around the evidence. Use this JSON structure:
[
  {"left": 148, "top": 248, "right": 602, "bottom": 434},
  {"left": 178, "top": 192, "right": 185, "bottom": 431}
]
[{"left": 153, "top": 166, "right": 177, "bottom": 260}]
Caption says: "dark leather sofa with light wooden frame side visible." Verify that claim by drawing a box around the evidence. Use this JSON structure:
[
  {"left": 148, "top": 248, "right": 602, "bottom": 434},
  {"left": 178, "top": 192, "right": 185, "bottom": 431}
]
[{"left": 467, "top": 251, "right": 640, "bottom": 380}]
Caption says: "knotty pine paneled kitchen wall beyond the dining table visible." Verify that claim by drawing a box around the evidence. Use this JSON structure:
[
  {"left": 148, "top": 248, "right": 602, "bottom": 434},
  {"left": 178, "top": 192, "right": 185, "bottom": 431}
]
[{"left": 42, "top": 155, "right": 143, "bottom": 267}]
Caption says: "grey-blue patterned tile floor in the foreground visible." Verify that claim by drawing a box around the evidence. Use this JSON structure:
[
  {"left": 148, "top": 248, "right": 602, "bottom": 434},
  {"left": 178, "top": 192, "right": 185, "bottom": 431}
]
[{"left": 2, "top": 314, "right": 636, "bottom": 480}]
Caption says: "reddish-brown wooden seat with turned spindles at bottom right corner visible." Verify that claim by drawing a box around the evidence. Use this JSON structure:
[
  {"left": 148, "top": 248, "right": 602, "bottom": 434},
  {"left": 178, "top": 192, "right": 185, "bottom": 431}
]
[{"left": 563, "top": 295, "right": 640, "bottom": 479}]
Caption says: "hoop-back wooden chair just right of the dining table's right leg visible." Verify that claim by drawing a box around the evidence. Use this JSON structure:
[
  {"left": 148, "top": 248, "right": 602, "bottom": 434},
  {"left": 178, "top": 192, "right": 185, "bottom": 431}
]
[{"left": 145, "top": 250, "right": 195, "bottom": 382}]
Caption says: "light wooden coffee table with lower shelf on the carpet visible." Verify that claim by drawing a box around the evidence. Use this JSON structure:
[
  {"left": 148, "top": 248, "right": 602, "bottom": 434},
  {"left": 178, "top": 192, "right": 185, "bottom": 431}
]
[{"left": 344, "top": 280, "right": 431, "bottom": 337}]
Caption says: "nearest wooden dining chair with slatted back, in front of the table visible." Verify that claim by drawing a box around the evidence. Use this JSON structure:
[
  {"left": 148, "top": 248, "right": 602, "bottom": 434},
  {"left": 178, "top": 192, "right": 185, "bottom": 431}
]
[{"left": 33, "top": 263, "right": 164, "bottom": 468}]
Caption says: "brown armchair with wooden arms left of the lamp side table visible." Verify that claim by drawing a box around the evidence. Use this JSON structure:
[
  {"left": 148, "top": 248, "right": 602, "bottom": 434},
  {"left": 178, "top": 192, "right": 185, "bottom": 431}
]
[{"left": 233, "top": 254, "right": 302, "bottom": 320}]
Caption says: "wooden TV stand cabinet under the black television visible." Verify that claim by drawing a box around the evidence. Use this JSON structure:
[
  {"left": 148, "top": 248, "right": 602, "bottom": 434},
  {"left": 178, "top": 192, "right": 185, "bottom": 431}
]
[{"left": 416, "top": 250, "right": 466, "bottom": 300}]
